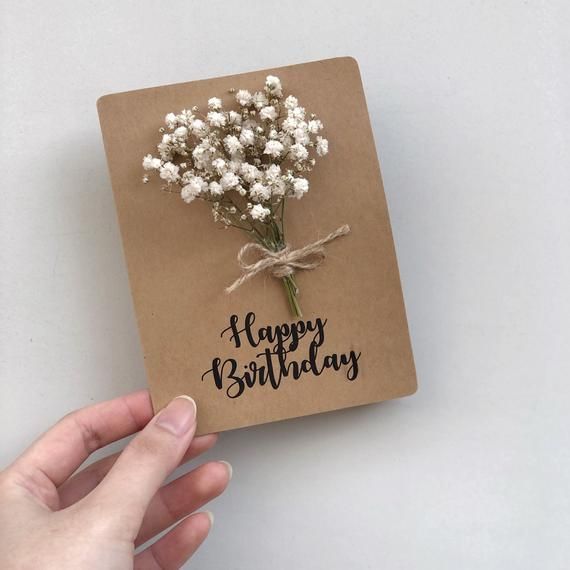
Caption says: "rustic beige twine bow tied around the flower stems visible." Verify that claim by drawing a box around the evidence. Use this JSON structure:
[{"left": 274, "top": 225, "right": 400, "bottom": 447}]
[{"left": 226, "top": 224, "right": 350, "bottom": 293}]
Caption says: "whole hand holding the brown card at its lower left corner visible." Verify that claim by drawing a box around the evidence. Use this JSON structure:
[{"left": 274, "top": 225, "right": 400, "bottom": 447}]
[{"left": 0, "top": 391, "right": 231, "bottom": 570}]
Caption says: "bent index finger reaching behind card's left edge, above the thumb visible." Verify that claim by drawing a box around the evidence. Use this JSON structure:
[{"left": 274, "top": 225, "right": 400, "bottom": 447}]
[{"left": 11, "top": 390, "right": 153, "bottom": 487}]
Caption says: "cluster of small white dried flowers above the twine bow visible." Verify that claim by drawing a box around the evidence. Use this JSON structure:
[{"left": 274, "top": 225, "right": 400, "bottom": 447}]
[{"left": 143, "top": 75, "right": 328, "bottom": 225}]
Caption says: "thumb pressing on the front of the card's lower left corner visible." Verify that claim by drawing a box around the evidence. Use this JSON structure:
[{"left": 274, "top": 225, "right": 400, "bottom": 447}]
[{"left": 83, "top": 396, "right": 196, "bottom": 536}]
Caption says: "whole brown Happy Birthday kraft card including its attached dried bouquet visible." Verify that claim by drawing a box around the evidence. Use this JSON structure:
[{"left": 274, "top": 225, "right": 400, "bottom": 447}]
[{"left": 98, "top": 57, "right": 416, "bottom": 434}]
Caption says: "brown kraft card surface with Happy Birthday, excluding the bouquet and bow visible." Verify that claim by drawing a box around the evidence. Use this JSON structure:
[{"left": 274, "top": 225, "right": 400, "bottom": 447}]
[{"left": 98, "top": 57, "right": 416, "bottom": 434}]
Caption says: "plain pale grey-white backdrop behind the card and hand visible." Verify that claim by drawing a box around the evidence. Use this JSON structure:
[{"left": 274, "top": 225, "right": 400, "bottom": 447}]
[{"left": 0, "top": 0, "right": 570, "bottom": 570}]
